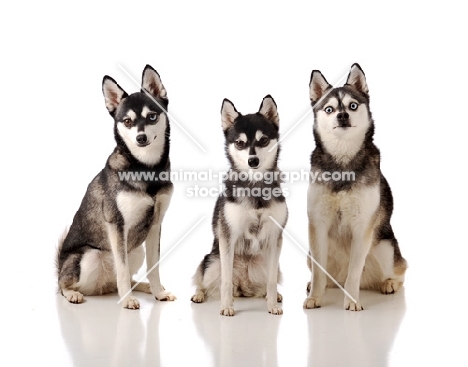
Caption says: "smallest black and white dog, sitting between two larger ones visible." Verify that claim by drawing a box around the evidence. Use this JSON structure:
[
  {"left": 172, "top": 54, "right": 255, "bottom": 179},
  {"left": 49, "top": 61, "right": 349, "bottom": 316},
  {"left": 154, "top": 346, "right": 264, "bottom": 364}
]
[{"left": 192, "top": 95, "right": 288, "bottom": 316}]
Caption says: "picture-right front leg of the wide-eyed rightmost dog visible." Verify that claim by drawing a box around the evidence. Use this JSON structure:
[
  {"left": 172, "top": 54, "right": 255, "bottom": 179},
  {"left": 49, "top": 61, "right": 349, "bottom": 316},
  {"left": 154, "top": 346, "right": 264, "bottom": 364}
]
[{"left": 344, "top": 227, "right": 372, "bottom": 311}]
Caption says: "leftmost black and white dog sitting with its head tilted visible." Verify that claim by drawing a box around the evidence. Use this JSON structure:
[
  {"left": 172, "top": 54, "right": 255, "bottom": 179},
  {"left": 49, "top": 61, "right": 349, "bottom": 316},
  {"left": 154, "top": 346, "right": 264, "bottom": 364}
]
[{"left": 56, "top": 65, "right": 175, "bottom": 309}]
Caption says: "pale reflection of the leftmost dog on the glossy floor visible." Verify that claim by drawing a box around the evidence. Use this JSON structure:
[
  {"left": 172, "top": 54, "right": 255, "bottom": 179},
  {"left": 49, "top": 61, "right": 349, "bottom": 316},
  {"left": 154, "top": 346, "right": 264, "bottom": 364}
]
[{"left": 57, "top": 295, "right": 161, "bottom": 367}]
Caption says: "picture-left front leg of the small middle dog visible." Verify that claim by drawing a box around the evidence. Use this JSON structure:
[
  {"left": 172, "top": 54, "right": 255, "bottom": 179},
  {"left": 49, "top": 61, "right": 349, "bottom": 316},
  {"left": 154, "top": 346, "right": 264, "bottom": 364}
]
[{"left": 219, "top": 231, "right": 236, "bottom": 316}]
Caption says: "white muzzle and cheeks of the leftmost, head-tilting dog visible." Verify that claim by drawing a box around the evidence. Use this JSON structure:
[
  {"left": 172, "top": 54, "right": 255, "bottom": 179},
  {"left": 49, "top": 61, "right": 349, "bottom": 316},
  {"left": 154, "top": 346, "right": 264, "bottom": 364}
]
[{"left": 117, "top": 113, "right": 167, "bottom": 166}]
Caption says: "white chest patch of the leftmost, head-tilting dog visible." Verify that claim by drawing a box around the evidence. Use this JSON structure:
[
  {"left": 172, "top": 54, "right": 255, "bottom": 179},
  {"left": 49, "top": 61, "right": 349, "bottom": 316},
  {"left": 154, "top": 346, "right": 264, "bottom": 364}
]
[{"left": 117, "top": 191, "right": 154, "bottom": 228}]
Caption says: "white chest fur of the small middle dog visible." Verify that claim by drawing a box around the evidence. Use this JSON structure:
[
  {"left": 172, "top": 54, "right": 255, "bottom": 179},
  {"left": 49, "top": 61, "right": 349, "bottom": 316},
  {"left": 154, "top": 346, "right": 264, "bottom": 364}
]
[{"left": 224, "top": 202, "right": 288, "bottom": 253}]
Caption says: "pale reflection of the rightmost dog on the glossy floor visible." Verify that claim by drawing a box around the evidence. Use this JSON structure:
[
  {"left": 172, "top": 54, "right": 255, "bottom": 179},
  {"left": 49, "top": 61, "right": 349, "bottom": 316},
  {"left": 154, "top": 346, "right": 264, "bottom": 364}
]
[{"left": 304, "top": 289, "right": 406, "bottom": 366}]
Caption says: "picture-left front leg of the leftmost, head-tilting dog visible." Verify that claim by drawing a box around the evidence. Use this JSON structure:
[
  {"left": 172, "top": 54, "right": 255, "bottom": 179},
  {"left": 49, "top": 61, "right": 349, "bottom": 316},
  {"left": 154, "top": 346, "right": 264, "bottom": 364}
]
[{"left": 107, "top": 223, "right": 140, "bottom": 310}]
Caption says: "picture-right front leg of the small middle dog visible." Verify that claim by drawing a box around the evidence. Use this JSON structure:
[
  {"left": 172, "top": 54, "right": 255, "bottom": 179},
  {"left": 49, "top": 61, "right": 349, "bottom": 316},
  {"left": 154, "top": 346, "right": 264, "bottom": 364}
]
[{"left": 266, "top": 235, "right": 283, "bottom": 315}]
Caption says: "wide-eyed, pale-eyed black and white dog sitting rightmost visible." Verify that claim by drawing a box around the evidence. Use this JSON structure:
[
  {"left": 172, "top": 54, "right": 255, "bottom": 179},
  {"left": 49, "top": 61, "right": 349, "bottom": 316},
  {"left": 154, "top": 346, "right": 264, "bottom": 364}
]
[{"left": 304, "top": 64, "right": 407, "bottom": 311}]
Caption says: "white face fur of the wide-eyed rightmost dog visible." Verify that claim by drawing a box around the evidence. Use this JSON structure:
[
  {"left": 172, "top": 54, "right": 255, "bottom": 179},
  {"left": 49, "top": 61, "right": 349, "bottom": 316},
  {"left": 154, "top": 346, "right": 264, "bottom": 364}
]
[{"left": 315, "top": 94, "right": 370, "bottom": 164}]
